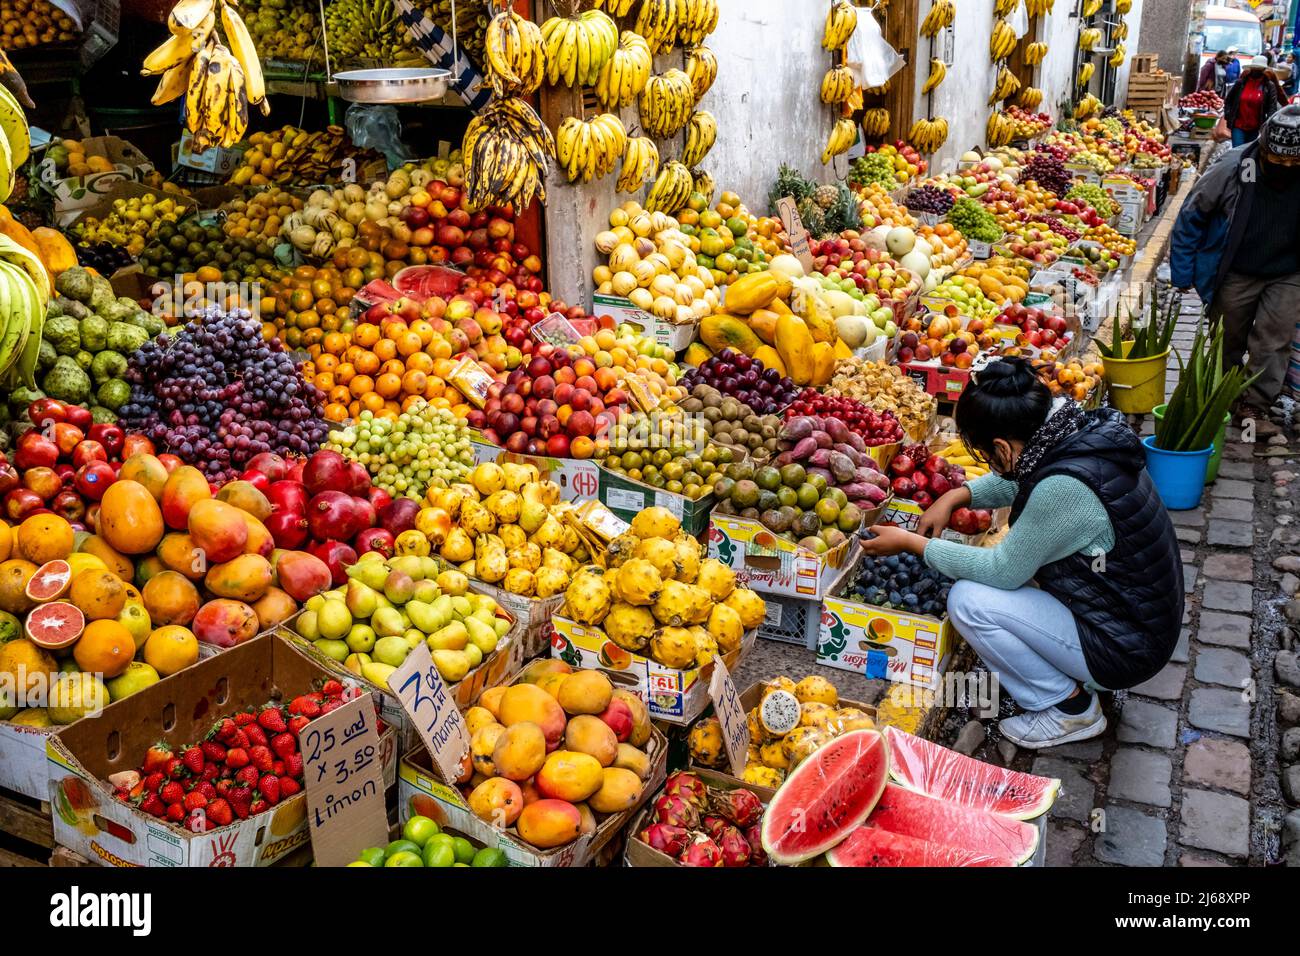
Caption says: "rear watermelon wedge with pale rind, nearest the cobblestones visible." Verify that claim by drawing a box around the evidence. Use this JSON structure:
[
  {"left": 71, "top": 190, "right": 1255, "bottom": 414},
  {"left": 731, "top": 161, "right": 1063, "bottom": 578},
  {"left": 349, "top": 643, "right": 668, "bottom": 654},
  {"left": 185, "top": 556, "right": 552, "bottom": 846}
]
[{"left": 885, "top": 727, "right": 1061, "bottom": 819}]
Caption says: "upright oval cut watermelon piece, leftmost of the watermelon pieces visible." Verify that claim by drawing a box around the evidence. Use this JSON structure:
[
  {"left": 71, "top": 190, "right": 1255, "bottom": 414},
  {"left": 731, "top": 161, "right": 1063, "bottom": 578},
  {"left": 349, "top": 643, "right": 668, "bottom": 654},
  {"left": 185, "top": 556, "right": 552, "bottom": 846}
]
[{"left": 763, "top": 730, "right": 889, "bottom": 865}]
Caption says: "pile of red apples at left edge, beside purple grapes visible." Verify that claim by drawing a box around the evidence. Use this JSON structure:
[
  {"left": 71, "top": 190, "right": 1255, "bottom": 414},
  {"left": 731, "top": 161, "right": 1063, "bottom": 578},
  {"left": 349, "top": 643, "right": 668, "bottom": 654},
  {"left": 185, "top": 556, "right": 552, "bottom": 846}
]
[{"left": 0, "top": 398, "right": 170, "bottom": 531}]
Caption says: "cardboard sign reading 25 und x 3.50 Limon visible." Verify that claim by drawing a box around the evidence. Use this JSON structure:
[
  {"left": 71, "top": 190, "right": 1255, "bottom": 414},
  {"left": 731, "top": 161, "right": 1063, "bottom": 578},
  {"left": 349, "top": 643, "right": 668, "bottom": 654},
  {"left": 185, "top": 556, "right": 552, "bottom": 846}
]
[{"left": 302, "top": 693, "right": 389, "bottom": 866}]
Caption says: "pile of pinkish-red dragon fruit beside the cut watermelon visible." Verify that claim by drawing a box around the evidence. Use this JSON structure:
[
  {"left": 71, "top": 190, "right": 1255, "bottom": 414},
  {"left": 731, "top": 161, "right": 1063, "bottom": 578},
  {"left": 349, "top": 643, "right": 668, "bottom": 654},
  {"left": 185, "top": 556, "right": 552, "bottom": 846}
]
[{"left": 638, "top": 770, "right": 767, "bottom": 866}]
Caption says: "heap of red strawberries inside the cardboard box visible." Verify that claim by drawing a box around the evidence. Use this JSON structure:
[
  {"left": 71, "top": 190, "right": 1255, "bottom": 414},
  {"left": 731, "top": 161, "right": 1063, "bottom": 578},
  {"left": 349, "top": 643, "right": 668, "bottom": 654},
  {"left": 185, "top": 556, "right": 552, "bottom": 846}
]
[{"left": 111, "top": 680, "right": 371, "bottom": 830}]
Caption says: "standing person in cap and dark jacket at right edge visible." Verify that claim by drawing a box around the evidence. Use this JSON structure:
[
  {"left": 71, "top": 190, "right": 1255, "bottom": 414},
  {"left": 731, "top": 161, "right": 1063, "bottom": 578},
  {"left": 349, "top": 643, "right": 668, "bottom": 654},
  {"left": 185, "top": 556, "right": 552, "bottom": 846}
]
[{"left": 1169, "top": 105, "right": 1300, "bottom": 423}]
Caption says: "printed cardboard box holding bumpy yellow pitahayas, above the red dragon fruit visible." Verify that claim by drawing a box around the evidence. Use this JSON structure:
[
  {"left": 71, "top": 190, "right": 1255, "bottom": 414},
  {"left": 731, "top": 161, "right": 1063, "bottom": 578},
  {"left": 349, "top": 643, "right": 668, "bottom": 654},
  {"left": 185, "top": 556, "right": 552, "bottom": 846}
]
[{"left": 551, "top": 615, "right": 758, "bottom": 724}]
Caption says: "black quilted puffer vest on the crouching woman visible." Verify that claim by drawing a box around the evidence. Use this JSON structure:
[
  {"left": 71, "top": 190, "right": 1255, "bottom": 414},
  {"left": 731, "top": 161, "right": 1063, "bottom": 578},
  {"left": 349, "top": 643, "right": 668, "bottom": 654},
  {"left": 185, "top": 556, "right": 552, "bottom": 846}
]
[{"left": 1010, "top": 408, "right": 1183, "bottom": 691}]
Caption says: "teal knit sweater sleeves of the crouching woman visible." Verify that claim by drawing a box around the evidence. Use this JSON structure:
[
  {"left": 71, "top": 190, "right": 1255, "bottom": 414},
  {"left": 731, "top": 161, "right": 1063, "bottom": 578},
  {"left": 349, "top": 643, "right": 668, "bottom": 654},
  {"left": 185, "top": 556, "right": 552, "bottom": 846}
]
[{"left": 926, "top": 472, "right": 1115, "bottom": 591}]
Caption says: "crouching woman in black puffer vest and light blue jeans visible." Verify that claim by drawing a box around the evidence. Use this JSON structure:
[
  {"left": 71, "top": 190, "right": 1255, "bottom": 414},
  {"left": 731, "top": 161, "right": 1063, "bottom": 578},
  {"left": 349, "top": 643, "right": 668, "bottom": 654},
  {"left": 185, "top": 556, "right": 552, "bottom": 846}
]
[{"left": 862, "top": 358, "right": 1183, "bottom": 749}]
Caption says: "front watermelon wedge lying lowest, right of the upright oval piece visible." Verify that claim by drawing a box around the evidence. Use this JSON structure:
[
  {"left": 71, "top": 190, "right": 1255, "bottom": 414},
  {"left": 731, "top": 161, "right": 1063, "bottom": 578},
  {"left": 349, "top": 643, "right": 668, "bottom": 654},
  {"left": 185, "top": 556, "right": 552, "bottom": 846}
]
[{"left": 867, "top": 783, "right": 1039, "bottom": 865}]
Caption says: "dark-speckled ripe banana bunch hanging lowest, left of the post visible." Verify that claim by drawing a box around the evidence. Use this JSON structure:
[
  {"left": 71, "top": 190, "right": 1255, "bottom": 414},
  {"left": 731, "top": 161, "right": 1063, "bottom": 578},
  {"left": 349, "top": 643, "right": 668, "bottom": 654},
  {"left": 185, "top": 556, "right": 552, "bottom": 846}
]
[{"left": 460, "top": 96, "right": 555, "bottom": 209}]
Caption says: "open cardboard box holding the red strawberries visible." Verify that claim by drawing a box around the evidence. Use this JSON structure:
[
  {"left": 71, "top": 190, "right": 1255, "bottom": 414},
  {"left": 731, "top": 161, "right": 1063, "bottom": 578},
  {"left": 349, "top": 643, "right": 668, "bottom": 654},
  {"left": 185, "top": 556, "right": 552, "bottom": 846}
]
[{"left": 47, "top": 635, "right": 398, "bottom": 866}]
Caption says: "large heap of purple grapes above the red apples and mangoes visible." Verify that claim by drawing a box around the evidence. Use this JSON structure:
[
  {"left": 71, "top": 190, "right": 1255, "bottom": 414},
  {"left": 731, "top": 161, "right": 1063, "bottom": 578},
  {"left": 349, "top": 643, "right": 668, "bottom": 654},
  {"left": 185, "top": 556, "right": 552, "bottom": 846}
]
[{"left": 118, "top": 306, "right": 329, "bottom": 483}]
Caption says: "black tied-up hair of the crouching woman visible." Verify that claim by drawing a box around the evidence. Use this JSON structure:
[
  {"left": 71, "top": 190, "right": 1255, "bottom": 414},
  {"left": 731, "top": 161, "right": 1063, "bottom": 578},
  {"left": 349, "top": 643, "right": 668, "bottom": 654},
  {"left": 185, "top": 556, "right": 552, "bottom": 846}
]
[{"left": 953, "top": 358, "right": 1052, "bottom": 459}]
